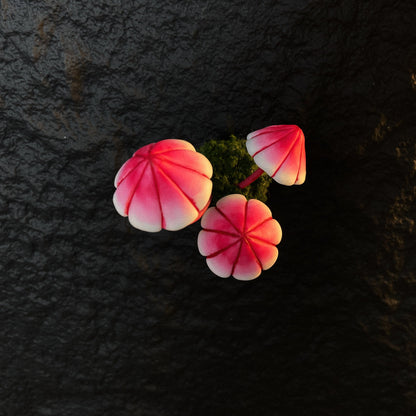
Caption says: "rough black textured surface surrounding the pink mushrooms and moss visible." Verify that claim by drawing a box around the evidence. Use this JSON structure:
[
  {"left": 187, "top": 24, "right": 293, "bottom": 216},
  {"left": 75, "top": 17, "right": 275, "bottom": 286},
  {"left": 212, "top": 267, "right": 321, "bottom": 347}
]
[{"left": 0, "top": 0, "right": 416, "bottom": 416}]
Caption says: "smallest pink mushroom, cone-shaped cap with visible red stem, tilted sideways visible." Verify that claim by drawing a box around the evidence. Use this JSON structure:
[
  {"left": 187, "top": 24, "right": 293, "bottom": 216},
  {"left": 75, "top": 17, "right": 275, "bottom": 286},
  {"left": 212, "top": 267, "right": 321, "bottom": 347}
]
[{"left": 238, "top": 125, "right": 306, "bottom": 189}]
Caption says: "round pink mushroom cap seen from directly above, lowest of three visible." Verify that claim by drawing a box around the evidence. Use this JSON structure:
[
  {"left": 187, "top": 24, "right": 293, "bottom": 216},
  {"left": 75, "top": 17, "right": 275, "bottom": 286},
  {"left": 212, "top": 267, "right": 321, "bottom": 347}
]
[{"left": 198, "top": 194, "right": 282, "bottom": 280}]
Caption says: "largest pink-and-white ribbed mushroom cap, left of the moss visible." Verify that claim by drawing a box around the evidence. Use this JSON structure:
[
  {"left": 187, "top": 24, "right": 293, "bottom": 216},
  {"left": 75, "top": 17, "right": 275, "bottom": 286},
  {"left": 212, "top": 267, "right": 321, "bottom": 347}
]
[{"left": 113, "top": 139, "right": 212, "bottom": 232}]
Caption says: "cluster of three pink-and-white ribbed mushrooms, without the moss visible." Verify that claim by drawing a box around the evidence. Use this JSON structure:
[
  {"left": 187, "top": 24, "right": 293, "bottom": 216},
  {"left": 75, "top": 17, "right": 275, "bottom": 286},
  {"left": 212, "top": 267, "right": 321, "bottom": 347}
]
[{"left": 113, "top": 125, "right": 306, "bottom": 280}]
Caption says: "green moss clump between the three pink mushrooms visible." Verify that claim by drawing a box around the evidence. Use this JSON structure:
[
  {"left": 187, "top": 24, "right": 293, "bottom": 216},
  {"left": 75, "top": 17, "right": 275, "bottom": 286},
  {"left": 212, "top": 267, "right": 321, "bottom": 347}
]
[{"left": 198, "top": 135, "right": 272, "bottom": 203}]
